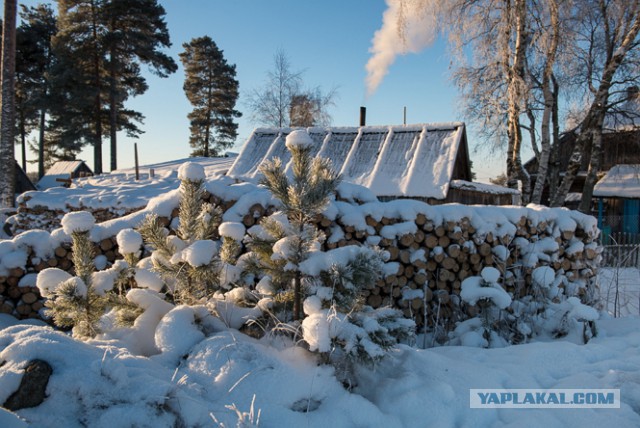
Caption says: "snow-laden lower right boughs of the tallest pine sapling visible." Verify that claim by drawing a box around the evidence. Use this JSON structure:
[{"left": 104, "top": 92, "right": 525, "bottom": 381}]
[{"left": 302, "top": 246, "right": 415, "bottom": 372}]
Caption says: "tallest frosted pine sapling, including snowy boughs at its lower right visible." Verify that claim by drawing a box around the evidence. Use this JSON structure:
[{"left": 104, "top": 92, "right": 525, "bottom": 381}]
[{"left": 247, "top": 130, "right": 415, "bottom": 376}]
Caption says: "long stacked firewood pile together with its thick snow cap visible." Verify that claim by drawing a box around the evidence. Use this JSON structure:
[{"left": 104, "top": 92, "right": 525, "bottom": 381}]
[{"left": 0, "top": 180, "right": 600, "bottom": 326}]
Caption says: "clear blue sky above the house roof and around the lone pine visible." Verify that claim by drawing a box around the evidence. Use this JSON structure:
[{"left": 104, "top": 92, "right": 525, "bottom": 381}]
[{"left": 20, "top": 0, "right": 504, "bottom": 181}]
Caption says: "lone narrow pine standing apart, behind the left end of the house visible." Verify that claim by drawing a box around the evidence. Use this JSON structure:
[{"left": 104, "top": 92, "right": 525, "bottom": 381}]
[{"left": 180, "top": 36, "right": 241, "bottom": 157}]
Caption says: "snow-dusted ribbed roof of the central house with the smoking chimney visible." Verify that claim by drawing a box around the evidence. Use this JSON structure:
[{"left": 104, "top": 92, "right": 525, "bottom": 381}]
[{"left": 227, "top": 122, "right": 466, "bottom": 199}]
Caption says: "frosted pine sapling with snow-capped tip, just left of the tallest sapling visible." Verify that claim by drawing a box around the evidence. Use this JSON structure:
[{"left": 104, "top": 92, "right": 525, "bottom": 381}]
[{"left": 139, "top": 162, "right": 222, "bottom": 304}]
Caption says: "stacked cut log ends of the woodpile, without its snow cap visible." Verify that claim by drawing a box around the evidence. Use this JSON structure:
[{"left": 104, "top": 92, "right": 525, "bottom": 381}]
[{"left": 0, "top": 195, "right": 600, "bottom": 328}]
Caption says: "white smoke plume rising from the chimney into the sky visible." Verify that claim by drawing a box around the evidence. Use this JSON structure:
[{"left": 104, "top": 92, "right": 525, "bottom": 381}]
[{"left": 365, "top": 0, "right": 437, "bottom": 96}]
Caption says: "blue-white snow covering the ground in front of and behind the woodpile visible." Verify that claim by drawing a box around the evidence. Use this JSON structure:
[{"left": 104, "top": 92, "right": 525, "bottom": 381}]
[{"left": 0, "top": 158, "right": 640, "bottom": 428}]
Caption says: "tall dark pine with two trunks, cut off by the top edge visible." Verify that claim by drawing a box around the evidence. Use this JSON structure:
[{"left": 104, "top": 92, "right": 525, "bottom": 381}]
[{"left": 52, "top": 0, "right": 177, "bottom": 173}]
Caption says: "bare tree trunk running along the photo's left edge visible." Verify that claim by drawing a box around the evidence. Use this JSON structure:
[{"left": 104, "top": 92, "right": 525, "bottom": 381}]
[{"left": 0, "top": 0, "right": 17, "bottom": 207}]
